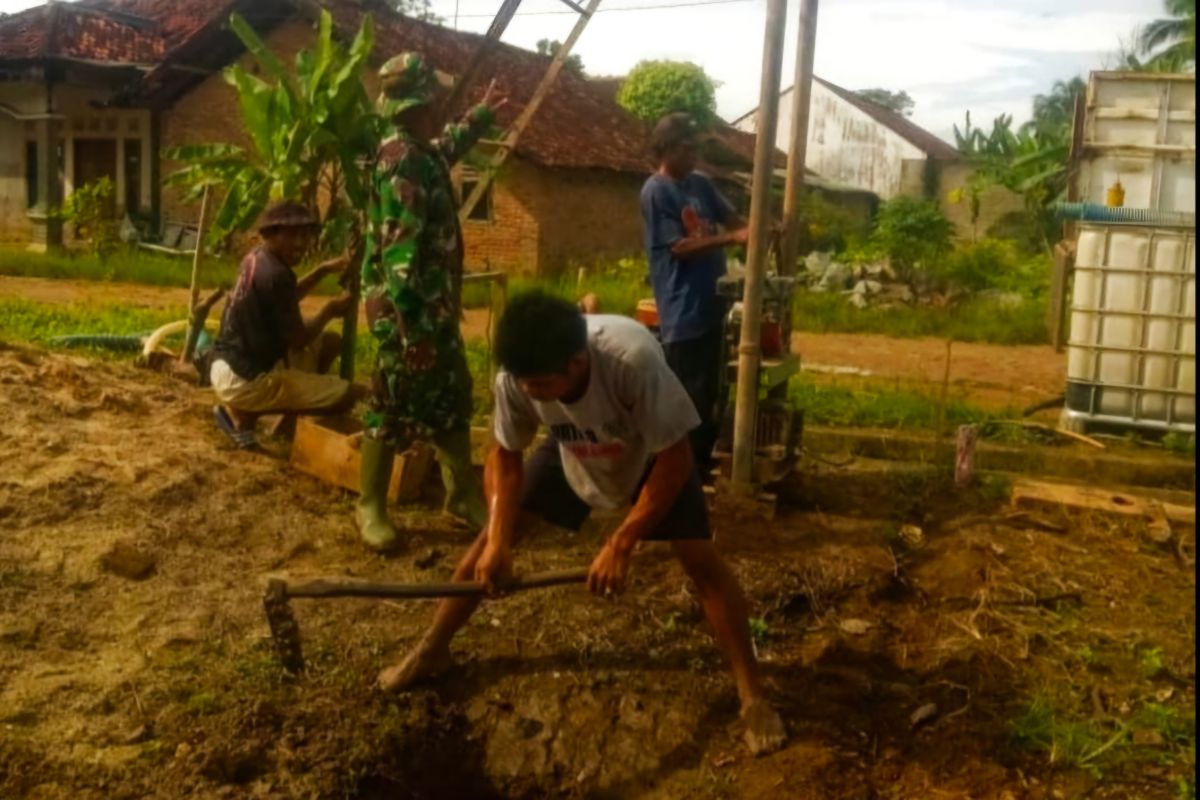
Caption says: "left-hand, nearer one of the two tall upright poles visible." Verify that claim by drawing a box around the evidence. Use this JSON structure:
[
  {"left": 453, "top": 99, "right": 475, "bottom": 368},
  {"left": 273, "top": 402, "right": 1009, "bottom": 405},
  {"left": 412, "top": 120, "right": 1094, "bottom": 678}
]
[{"left": 730, "top": 0, "right": 787, "bottom": 493}]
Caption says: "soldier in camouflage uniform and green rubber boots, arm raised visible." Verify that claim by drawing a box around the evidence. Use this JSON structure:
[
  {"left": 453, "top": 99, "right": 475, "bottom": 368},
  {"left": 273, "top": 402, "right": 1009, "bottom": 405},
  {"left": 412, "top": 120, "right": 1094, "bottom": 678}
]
[{"left": 358, "top": 53, "right": 503, "bottom": 549}]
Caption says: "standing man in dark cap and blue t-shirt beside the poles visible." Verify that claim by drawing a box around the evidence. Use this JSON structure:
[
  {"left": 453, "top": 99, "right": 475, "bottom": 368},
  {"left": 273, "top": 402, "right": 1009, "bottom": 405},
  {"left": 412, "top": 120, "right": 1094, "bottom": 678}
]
[{"left": 642, "top": 114, "right": 749, "bottom": 475}]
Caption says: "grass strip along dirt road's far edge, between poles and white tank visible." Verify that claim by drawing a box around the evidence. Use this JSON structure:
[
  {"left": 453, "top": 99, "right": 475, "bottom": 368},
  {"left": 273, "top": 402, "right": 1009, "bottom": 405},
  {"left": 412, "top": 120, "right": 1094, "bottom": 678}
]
[{"left": 792, "top": 289, "right": 1049, "bottom": 344}]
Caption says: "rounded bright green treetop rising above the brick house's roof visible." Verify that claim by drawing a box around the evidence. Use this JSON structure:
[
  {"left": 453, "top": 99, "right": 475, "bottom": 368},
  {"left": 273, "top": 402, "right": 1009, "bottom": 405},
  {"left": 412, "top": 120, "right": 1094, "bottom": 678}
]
[{"left": 617, "top": 61, "right": 716, "bottom": 126}]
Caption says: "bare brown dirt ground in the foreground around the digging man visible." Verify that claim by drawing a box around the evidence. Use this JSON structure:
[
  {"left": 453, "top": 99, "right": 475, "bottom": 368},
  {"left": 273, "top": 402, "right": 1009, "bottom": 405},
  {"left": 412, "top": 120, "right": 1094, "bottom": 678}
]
[{"left": 0, "top": 345, "right": 1195, "bottom": 800}]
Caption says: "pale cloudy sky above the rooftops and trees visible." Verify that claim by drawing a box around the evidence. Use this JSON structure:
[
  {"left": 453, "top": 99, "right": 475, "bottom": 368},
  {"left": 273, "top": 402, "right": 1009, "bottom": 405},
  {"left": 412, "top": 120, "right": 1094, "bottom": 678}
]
[{"left": 0, "top": 0, "right": 1163, "bottom": 143}]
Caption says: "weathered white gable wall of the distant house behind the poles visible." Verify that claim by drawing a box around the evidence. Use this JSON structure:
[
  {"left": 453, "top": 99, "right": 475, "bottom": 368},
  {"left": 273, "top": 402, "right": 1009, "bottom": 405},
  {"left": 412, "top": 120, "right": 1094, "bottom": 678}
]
[{"left": 737, "top": 80, "right": 926, "bottom": 200}]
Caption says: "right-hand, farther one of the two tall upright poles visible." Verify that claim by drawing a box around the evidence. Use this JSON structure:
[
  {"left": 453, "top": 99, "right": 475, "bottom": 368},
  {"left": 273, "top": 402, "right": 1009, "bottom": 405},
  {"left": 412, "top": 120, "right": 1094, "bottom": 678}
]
[{"left": 779, "top": 0, "right": 817, "bottom": 275}]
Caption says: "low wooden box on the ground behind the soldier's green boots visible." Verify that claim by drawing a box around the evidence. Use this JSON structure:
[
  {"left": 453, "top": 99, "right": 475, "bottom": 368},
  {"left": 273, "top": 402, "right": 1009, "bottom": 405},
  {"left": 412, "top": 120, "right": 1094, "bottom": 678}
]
[{"left": 292, "top": 416, "right": 433, "bottom": 503}]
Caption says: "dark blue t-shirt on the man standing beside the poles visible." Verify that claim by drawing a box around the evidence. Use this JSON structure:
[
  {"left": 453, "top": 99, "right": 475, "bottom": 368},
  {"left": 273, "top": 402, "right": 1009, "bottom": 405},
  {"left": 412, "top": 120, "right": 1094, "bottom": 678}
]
[{"left": 642, "top": 173, "right": 734, "bottom": 343}]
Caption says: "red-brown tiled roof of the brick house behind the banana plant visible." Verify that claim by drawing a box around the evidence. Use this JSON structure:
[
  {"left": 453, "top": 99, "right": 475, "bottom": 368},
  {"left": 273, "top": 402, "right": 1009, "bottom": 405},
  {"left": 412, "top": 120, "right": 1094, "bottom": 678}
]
[{"left": 0, "top": 0, "right": 777, "bottom": 174}]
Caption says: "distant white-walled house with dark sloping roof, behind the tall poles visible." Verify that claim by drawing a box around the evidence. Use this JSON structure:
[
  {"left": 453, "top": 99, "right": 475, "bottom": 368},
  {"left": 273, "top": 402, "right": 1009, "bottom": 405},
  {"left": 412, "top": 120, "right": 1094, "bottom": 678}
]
[{"left": 733, "top": 77, "right": 960, "bottom": 200}]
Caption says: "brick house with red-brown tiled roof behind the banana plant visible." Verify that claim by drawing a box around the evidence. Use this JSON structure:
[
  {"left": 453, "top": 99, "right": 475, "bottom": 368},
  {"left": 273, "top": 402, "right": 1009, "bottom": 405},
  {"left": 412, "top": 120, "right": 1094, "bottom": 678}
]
[{"left": 0, "top": 0, "right": 755, "bottom": 275}]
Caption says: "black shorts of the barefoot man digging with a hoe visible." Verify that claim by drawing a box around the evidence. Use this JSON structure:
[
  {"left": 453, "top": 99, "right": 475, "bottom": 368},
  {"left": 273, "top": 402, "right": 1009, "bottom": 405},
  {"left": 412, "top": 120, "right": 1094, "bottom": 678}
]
[{"left": 521, "top": 439, "right": 713, "bottom": 541}]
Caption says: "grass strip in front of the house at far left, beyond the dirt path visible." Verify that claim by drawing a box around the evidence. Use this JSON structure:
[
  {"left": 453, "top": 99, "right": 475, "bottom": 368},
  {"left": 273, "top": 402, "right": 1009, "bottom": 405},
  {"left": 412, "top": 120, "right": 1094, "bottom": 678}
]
[{"left": 0, "top": 247, "right": 238, "bottom": 292}]
